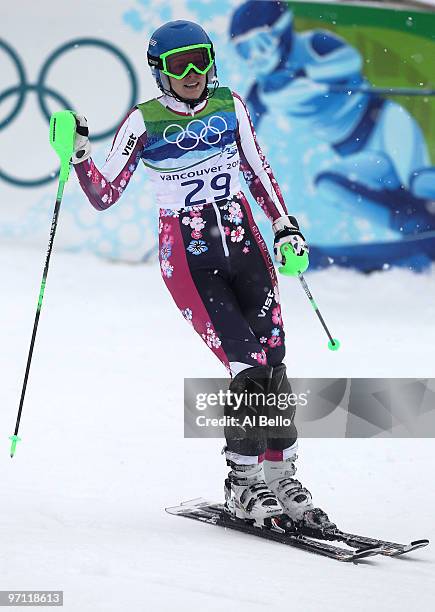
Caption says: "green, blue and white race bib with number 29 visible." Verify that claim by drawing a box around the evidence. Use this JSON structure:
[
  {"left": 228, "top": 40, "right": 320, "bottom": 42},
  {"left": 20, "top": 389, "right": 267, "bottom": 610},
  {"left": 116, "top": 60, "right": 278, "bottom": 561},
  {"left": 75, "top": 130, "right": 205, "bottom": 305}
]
[{"left": 138, "top": 87, "right": 241, "bottom": 208}]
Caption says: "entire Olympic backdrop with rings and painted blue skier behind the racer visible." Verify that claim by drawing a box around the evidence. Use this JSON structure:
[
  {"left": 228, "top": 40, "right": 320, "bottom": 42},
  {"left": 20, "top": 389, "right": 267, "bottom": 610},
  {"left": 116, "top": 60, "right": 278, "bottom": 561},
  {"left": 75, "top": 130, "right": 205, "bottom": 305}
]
[{"left": 0, "top": 0, "right": 435, "bottom": 271}]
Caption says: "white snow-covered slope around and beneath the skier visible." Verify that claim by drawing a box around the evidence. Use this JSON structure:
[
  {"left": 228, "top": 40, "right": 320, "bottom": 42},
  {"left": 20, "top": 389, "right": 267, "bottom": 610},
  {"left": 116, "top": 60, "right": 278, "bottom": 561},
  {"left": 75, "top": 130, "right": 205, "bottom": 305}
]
[{"left": 0, "top": 246, "right": 435, "bottom": 612}]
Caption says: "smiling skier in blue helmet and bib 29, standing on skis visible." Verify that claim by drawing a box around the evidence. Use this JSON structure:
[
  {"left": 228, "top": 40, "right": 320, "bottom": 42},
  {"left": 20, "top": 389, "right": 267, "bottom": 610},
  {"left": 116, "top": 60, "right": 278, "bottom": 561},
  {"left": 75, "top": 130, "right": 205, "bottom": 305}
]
[{"left": 72, "top": 16, "right": 328, "bottom": 526}]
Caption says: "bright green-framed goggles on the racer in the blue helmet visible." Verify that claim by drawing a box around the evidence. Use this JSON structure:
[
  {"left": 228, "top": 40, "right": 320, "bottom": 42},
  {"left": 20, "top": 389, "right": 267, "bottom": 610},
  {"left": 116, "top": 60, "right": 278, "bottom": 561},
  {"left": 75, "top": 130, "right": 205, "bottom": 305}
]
[{"left": 158, "top": 44, "right": 214, "bottom": 80}]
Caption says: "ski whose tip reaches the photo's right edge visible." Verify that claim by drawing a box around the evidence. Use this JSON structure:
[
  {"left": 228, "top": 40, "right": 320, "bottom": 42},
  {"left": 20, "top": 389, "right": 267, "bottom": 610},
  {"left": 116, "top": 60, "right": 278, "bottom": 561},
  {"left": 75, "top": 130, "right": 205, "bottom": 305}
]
[{"left": 301, "top": 528, "right": 429, "bottom": 557}]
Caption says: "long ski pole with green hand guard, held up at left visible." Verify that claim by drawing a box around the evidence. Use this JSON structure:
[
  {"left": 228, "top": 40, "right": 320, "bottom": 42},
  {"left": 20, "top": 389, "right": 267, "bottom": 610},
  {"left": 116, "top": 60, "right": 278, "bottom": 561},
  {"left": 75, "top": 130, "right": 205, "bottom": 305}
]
[{"left": 9, "top": 110, "right": 76, "bottom": 458}]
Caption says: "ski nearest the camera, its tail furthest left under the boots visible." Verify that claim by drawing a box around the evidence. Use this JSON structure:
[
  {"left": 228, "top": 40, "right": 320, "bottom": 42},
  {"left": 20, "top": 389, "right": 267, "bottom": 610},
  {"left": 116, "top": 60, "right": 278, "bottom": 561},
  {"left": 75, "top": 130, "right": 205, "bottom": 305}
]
[{"left": 166, "top": 498, "right": 381, "bottom": 562}]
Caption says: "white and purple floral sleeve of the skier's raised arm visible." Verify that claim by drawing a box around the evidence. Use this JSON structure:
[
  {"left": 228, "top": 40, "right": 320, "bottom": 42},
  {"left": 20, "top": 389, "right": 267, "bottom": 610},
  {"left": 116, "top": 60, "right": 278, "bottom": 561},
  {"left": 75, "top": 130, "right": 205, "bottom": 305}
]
[{"left": 74, "top": 108, "right": 146, "bottom": 210}]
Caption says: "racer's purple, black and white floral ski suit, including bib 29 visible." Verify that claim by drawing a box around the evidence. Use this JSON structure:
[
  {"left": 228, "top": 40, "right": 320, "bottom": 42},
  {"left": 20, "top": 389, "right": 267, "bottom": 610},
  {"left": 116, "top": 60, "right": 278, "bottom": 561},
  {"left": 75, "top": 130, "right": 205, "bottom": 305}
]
[{"left": 75, "top": 87, "right": 297, "bottom": 463}]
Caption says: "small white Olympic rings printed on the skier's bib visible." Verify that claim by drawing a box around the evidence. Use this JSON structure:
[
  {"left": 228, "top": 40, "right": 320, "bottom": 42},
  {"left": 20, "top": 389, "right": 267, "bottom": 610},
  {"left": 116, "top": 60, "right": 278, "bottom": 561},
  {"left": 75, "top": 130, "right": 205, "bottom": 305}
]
[{"left": 163, "top": 115, "right": 228, "bottom": 151}]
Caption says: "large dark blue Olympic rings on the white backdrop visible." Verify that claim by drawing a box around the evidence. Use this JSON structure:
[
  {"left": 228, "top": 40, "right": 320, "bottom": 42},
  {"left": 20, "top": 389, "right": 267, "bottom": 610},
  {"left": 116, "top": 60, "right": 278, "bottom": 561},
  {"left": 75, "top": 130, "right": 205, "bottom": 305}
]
[{"left": 0, "top": 38, "right": 138, "bottom": 187}]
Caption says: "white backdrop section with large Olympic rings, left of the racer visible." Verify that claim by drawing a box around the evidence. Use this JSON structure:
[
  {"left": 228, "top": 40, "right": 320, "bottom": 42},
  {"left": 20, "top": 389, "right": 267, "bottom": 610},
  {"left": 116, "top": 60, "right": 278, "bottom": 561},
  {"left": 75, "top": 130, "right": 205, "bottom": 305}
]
[{"left": 0, "top": 0, "right": 158, "bottom": 261}]
